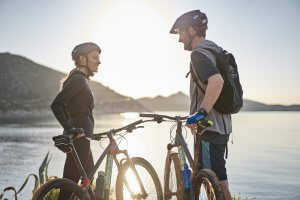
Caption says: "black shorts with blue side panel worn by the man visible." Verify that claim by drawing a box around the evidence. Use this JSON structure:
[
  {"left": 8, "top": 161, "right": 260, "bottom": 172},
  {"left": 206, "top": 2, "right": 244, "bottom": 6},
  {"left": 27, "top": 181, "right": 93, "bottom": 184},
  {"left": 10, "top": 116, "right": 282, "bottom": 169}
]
[{"left": 199, "top": 140, "right": 227, "bottom": 181}]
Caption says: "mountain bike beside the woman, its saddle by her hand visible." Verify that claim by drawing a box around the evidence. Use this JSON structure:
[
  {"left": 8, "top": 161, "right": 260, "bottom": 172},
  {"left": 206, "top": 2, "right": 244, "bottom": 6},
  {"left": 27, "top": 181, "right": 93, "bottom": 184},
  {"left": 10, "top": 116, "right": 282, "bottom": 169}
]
[{"left": 33, "top": 120, "right": 163, "bottom": 200}]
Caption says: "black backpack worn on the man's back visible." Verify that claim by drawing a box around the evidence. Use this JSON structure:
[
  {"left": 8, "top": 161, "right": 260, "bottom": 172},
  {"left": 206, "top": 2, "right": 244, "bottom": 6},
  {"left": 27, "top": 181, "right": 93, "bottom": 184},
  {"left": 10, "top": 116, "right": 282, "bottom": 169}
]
[{"left": 190, "top": 48, "right": 243, "bottom": 114}]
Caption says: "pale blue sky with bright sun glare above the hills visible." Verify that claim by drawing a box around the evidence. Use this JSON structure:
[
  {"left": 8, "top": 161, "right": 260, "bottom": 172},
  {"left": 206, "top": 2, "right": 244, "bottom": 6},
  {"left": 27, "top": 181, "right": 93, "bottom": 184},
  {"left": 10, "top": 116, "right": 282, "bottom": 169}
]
[{"left": 0, "top": 0, "right": 300, "bottom": 105}]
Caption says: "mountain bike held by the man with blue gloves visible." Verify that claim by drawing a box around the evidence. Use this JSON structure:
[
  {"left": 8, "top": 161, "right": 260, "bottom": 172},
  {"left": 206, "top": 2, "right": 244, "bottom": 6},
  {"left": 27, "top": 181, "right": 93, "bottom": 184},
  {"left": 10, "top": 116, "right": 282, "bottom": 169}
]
[{"left": 140, "top": 114, "right": 224, "bottom": 200}]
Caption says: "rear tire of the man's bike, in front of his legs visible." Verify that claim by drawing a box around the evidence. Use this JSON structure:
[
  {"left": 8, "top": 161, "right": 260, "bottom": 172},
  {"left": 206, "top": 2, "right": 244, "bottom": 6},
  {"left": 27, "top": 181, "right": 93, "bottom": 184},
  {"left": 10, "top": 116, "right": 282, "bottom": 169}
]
[{"left": 192, "top": 169, "right": 224, "bottom": 200}]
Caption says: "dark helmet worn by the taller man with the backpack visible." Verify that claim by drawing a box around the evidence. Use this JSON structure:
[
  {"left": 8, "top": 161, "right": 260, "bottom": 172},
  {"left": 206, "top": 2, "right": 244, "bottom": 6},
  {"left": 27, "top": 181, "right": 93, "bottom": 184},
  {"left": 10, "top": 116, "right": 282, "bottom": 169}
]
[{"left": 170, "top": 10, "right": 208, "bottom": 34}]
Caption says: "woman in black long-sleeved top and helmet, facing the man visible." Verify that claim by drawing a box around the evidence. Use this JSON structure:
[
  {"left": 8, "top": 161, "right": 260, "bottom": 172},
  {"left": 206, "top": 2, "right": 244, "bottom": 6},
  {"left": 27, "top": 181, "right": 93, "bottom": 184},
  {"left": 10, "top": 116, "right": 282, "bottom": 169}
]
[{"left": 51, "top": 42, "right": 101, "bottom": 199}]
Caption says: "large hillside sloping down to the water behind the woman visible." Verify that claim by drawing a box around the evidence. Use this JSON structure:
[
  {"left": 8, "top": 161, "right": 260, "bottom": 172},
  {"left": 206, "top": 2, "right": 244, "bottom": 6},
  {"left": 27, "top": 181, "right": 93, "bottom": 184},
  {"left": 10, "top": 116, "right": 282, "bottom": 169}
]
[{"left": 0, "top": 53, "right": 148, "bottom": 113}]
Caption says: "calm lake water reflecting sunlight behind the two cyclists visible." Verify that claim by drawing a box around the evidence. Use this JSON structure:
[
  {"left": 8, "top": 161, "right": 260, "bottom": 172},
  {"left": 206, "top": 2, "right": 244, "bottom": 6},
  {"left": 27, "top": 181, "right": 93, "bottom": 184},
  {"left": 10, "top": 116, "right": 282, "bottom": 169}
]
[{"left": 0, "top": 112, "right": 300, "bottom": 200}]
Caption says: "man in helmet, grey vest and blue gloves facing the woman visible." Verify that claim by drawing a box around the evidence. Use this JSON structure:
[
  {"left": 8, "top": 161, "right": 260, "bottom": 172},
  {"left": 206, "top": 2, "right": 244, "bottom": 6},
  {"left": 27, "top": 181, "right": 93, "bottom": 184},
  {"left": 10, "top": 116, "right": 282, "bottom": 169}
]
[{"left": 170, "top": 10, "right": 232, "bottom": 200}]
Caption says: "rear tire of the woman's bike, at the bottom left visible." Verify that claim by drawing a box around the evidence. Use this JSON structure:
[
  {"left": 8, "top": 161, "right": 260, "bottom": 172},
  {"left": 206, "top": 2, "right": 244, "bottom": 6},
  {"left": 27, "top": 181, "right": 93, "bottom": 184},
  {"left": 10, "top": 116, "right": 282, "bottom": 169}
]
[{"left": 32, "top": 178, "right": 84, "bottom": 200}]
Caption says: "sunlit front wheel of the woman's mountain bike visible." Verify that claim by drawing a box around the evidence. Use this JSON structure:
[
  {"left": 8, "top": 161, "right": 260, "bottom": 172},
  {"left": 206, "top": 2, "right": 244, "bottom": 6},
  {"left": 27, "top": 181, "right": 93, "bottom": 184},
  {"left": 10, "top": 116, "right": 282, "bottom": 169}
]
[{"left": 116, "top": 157, "right": 163, "bottom": 200}]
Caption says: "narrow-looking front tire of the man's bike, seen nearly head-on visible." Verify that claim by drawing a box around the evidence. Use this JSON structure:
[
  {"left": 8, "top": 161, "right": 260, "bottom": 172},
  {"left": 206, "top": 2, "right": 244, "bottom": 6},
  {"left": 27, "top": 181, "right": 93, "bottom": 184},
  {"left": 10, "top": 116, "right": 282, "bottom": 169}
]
[{"left": 164, "top": 153, "right": 185, "bottom": 200}]
